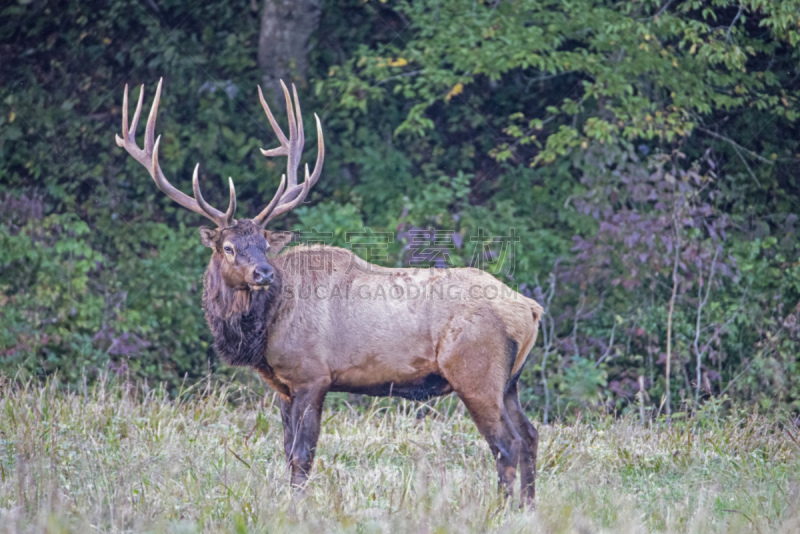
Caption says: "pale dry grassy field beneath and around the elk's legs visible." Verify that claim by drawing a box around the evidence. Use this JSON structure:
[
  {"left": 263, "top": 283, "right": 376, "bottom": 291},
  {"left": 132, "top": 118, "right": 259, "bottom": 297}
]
[{"left": 0, "top": 377, "right": 800, "bottom": 534}]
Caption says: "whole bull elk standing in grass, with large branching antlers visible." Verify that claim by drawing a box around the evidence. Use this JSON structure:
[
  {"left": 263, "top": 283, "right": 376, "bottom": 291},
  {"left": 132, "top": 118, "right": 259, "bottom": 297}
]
[{"left": 116, "top": 80, "right": 543, "bottom": 502}]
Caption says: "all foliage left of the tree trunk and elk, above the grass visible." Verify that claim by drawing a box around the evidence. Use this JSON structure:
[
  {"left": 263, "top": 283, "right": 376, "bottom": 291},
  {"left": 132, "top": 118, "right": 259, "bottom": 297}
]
[{"left": 0, "top": 1, "right": 266, "bottom": 394}]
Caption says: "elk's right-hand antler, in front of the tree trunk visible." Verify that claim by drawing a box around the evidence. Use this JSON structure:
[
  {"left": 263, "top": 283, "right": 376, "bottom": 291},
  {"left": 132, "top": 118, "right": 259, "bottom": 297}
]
[{"left": 253, "top": 81, "right": 325, "bottom": 226}]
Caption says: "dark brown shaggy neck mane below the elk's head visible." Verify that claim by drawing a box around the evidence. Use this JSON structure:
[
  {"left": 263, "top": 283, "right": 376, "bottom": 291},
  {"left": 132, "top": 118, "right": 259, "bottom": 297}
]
[{"left": 203, "top": 255, "right": 281, "bottom": 368}]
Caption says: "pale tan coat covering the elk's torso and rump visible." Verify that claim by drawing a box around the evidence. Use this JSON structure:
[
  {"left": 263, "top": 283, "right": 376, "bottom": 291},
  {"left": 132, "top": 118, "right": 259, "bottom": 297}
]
[{"left": 267, "top": 246, "right": 542, "bottom": 408}]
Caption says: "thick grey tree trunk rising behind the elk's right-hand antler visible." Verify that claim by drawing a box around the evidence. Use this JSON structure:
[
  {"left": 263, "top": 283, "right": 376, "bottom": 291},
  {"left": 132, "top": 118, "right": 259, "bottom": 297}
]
[{"left": 258, "top": 0, "right": 320, "bottom": 102}]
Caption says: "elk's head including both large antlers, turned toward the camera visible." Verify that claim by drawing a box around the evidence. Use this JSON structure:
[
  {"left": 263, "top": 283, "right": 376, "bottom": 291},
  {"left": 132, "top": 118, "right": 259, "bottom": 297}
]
[{"left": 116, "top": 79, "right": 325, "bottom": 290}]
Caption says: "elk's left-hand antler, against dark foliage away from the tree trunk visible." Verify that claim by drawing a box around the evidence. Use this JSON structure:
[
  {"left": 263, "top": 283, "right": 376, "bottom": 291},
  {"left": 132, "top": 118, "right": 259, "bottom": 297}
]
[{"left": 116, "top": 78, "right": 236, "bottom": 228}]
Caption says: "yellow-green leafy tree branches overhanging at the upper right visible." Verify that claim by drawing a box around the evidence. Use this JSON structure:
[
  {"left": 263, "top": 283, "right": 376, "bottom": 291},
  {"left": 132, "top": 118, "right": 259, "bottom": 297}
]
[{"left": 324, "top": 0, "right": 800, "bottom": 164}]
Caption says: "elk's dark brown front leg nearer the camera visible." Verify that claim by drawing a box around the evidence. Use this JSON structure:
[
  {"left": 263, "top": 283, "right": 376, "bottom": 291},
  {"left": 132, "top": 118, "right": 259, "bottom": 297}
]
[{"left": 284, "top": 383, "right": 328, "bottom": 487}]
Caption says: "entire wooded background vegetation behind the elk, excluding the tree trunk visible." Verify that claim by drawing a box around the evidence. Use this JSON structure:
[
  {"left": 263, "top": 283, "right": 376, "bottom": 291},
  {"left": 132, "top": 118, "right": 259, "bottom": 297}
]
[{"left": 0, "top": 0, "right": 800, "bottom": 421}]
